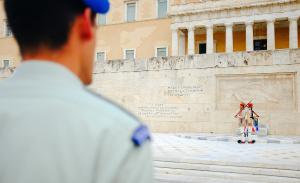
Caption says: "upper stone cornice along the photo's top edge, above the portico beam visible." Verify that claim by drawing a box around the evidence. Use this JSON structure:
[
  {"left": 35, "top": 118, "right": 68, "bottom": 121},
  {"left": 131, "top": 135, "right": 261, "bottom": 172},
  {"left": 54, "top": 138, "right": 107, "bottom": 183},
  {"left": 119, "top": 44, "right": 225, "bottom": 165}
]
[{"left": 169, "top": 0, "right": 297, "bottom": 16}]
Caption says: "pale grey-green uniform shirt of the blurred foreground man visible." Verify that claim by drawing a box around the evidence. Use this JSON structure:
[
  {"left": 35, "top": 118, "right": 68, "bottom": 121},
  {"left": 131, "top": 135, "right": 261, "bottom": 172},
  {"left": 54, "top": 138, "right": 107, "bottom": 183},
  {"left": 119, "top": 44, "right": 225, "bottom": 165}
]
[{"left": 0, "top": 61, "right": 153, "bottom": 183}]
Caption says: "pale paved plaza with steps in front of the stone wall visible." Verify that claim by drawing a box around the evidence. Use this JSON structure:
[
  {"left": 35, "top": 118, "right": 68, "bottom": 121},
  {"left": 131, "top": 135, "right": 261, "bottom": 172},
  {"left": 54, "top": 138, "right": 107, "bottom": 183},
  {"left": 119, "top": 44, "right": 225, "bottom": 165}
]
[{"left": 153, "top": 134, "right": 300, "bottom": 183}]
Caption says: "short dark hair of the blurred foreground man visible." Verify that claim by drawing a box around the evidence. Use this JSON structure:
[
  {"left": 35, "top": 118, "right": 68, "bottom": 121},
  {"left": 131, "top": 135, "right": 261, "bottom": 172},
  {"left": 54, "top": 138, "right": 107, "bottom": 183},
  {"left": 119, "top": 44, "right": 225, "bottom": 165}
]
[{"left": 4, "top": 0, "right": 95, "bottom": 54}]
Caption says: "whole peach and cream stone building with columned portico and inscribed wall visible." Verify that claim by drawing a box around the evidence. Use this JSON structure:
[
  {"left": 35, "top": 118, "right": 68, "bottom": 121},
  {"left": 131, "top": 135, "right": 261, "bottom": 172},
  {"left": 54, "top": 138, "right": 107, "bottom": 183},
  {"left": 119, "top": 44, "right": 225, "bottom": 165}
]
[{"left": 0, "top": 0, "right": 300, "bottom": 135}]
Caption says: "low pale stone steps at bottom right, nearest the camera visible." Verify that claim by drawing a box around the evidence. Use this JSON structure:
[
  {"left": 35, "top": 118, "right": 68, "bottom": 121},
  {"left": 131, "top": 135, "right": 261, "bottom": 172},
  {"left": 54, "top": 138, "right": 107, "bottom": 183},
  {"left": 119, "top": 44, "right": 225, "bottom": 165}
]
[{"left": 154, "top": 161, "right": 300, "bottom": 183}]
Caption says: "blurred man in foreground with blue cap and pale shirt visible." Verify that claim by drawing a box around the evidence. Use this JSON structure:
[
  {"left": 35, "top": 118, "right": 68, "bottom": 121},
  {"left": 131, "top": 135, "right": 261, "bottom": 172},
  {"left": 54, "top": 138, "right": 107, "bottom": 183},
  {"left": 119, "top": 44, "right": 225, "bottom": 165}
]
[{"left": 0, "top": 0, "right": 153, "bottom": 183}]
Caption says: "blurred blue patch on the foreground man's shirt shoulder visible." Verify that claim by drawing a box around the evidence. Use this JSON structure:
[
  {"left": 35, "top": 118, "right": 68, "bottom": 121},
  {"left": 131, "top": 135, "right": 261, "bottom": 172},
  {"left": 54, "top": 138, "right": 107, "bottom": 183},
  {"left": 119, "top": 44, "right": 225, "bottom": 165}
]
[{"left": 131, "top": 125, "right": 151, "bottom": 146}]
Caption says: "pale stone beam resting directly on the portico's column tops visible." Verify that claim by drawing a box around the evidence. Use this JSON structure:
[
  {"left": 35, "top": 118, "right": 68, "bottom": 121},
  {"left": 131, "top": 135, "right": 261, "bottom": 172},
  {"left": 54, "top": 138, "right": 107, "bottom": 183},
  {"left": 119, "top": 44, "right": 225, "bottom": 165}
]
[{"left": 173, "top": 3, "right": 300, "bottom": 28}]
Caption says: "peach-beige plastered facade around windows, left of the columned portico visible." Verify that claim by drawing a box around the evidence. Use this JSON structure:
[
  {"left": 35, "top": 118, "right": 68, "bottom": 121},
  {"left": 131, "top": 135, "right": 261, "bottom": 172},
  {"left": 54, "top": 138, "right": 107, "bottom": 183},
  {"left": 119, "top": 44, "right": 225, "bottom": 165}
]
[{"left": 0, "top": 0, "right": 172, "bottom": 64}]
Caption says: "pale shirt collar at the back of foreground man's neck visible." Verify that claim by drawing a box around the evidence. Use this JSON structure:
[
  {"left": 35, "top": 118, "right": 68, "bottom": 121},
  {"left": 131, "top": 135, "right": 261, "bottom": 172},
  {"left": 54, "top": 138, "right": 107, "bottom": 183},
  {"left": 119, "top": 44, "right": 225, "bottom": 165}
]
[{"left": 11, "top": 60, "right": 83, "bottom": 88}]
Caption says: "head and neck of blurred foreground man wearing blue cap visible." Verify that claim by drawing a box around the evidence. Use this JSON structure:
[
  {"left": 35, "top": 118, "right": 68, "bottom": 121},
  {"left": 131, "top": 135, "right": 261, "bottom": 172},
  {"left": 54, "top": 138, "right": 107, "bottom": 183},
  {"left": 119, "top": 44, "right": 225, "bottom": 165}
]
[{"left": 4, "top": 0, "right": 109, "bottom": 84}]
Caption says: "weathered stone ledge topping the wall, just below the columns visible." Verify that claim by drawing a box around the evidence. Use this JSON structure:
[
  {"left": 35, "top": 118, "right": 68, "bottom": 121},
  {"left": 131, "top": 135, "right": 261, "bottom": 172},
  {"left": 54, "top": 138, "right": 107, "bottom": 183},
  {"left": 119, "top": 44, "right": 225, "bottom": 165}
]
[{"left": 94, "top": 49, "right": 300, "bottom": 74}]
